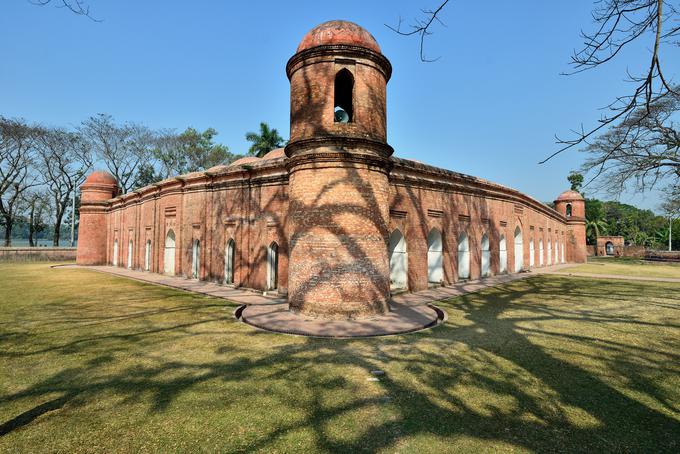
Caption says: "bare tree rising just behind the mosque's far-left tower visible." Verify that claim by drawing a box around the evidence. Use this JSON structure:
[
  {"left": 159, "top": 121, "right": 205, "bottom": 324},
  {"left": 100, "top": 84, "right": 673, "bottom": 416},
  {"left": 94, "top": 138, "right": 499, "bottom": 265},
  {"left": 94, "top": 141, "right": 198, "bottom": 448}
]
[{"left": 78, "top": 114, "right": 153, "bottom": 193}]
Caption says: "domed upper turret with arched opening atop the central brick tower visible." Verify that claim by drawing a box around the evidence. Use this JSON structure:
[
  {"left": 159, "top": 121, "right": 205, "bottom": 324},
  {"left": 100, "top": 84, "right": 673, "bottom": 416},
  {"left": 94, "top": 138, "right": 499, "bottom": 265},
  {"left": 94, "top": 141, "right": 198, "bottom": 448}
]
[{"left": 286, "top": 20, "right": 392, "bottom": 151}]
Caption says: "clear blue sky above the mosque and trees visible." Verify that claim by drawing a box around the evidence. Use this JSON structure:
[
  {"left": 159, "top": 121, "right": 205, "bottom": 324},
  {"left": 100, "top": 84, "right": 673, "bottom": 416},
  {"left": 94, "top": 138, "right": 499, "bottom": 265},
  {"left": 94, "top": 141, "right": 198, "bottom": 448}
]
[{"left": 0, "top": 0, "right": 680, "bottom": 209}]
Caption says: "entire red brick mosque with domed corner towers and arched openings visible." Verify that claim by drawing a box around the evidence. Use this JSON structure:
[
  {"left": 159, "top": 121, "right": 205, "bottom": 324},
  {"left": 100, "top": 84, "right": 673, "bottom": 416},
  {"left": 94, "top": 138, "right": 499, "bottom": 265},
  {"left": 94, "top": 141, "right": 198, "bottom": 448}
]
[{"left": 77, "top": 21, "right": 586, "bottom": 320}]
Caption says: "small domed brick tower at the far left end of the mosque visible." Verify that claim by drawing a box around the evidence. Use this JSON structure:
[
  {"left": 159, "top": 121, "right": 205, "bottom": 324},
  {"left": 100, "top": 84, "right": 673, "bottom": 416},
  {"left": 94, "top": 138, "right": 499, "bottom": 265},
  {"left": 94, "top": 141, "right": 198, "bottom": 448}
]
[{"left": 76, "top": 171, "right": 118, "bottom": 265}]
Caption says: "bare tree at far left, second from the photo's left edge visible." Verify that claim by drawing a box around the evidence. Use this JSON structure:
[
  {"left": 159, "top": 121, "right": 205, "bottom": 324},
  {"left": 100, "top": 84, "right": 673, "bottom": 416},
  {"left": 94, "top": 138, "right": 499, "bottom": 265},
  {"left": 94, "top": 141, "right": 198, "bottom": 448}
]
[{"left": 36, "top": 128, "right": 92, "bottom": 246}]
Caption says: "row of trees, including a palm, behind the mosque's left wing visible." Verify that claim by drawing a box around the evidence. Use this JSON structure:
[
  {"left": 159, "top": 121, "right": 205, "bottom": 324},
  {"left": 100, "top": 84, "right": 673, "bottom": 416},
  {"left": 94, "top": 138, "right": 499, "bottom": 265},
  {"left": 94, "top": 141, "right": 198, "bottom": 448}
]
[{"left": 0, "top": 114, "right": 285, "bottom": 246}]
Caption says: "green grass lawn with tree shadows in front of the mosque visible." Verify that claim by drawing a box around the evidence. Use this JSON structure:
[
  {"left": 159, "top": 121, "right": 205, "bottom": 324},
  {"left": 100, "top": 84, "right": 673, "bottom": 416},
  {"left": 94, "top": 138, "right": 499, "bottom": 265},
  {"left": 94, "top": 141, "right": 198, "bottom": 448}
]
[{"left": 0, "top": 264, "right": 680, "bottom": 453}]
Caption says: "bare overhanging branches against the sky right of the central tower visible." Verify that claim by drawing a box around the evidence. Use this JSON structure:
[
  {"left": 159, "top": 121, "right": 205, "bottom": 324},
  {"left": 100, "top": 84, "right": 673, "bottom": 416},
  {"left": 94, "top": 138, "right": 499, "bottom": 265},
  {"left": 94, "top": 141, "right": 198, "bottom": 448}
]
[{"left": 388, "top": 0, "right": 680, "bottom": 181}]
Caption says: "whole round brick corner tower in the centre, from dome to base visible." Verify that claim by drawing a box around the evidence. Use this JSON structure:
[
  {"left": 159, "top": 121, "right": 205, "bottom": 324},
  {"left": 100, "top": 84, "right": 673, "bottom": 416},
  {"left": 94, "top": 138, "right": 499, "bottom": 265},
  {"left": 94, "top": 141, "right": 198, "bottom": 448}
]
[{"left": 286, "top": 21, "right": 393, "bottom": 318}]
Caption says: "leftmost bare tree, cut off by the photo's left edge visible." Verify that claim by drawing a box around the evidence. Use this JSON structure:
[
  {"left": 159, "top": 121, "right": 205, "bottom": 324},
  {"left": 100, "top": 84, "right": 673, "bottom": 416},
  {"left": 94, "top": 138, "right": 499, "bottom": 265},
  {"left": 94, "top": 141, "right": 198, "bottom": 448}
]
[{"left": 0, "top": 117, "right": 39, "bottom": 246}]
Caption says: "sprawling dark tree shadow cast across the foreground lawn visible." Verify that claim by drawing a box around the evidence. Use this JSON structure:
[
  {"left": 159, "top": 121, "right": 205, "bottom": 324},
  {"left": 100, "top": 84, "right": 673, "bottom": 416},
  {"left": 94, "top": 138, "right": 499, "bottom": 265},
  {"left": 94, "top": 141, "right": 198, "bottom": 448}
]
[{"left": 0, "top": 278, "right": 680, "bottom": 452}]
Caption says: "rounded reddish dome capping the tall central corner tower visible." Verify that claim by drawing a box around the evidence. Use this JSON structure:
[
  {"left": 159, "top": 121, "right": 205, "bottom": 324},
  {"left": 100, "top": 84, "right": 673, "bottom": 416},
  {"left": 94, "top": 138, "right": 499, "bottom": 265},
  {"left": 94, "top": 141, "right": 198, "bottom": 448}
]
[{"left": 297, "top": 20, "right": 380, "bottom": 53}]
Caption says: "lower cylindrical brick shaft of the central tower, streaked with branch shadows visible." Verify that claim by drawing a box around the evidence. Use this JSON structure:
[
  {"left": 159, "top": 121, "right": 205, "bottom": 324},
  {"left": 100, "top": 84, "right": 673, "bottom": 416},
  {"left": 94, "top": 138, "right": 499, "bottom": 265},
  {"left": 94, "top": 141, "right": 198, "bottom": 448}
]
[{"left": 289, "top": 157, "right": 389, "bottom": 318}]
